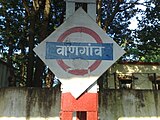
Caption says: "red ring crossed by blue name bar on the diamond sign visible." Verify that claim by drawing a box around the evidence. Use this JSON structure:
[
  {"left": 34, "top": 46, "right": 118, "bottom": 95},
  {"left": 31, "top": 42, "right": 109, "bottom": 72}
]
[{"left": 46, "top": 27, "right": 113, "bottom": 76}]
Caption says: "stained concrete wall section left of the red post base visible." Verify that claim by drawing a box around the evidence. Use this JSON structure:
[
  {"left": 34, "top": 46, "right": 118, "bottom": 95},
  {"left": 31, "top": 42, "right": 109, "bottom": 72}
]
[{"left": 0, "top": 88, "right": 60, "bottom": 120}]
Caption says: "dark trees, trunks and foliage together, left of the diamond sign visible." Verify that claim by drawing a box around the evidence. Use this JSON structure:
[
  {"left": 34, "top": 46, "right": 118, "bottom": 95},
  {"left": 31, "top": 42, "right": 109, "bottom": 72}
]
[{"left": 0, "top": 0, "right": 65, "bottom": 86}]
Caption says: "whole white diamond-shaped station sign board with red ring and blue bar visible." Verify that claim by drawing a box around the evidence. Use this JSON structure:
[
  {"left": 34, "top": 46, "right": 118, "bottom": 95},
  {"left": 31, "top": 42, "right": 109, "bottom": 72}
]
[{"left": 34, "top": 8, "right": 125, "bottom": 98}]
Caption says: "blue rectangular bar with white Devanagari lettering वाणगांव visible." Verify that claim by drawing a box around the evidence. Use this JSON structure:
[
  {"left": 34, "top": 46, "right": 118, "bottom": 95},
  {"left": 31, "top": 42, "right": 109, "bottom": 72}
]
[{"left": 46, "top": 42, "right": 113, "bottom": 60}]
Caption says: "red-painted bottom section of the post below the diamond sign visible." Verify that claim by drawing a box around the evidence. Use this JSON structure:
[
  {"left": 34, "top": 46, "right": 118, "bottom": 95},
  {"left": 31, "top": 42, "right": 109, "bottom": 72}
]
[{"left": 60, "top": 93, "right": 98, "bottom": 120}]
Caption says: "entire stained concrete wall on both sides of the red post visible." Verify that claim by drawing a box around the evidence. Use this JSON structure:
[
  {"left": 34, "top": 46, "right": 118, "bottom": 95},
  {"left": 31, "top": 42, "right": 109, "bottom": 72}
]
[{"left": 0, "top": 88, "right": 160, "bottom": 120}]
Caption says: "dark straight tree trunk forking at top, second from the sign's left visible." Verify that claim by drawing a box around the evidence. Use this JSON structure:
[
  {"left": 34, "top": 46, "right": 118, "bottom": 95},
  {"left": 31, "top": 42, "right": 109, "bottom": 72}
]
[{"left": 22, "top": 0, "right": 38, "bottom": 87}]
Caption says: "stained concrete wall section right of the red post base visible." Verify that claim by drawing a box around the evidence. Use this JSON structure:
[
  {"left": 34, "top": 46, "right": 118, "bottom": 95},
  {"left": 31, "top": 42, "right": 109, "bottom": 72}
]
[{"left": 99, "top": 90, "right": 160, "bottom": 120}]
